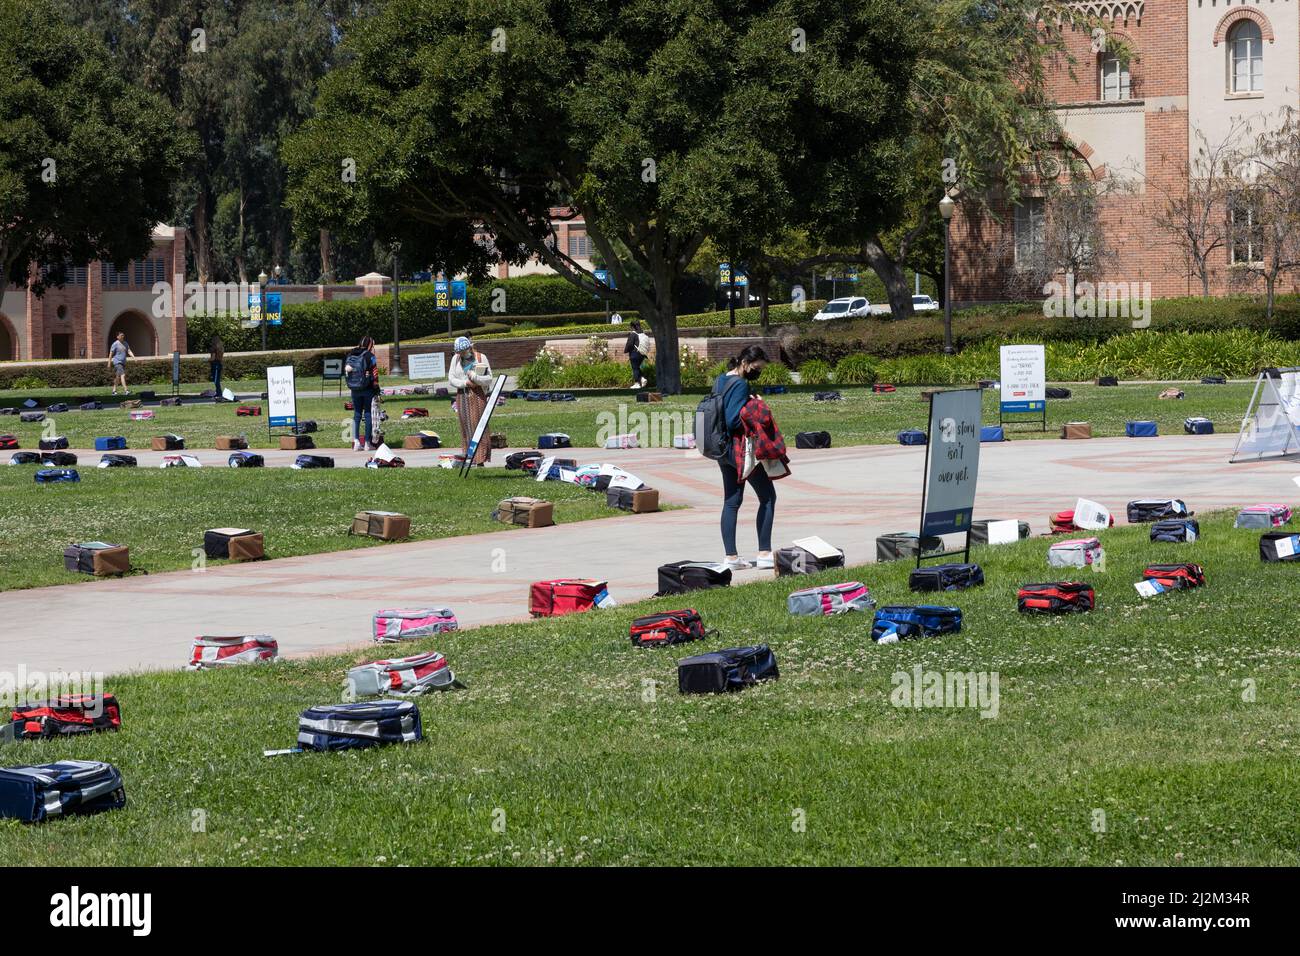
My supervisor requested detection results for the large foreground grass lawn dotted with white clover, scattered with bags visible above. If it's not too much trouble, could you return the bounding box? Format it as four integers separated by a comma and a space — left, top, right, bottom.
0, 515, 1300, 866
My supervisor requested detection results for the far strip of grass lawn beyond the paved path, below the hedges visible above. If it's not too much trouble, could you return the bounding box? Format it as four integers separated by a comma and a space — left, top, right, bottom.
0, 384, 1255, 460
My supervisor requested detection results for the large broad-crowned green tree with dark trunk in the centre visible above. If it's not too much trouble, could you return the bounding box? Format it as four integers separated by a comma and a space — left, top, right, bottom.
286, 0, 928, 393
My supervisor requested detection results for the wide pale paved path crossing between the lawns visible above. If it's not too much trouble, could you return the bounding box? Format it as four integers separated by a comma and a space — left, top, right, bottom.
0, 436, 1300, 672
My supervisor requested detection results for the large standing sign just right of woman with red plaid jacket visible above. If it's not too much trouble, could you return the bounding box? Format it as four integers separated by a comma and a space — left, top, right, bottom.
920, 389, 982, 535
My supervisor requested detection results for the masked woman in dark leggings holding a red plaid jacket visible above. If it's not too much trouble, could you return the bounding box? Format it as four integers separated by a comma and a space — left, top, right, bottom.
714, 345, 789, 570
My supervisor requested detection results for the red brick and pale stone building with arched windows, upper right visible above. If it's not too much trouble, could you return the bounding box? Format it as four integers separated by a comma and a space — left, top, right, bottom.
953, 0, 1300, 302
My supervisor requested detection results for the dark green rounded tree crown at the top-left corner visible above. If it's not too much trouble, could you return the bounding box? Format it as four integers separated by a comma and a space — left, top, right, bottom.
0, 0, 186, 293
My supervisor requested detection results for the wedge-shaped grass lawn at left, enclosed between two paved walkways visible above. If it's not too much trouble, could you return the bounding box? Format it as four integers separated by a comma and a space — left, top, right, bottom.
0, 467, 624, 591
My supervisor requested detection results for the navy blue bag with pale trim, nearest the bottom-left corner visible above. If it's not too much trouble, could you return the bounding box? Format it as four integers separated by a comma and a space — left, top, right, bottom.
0, 760, 126, 823
